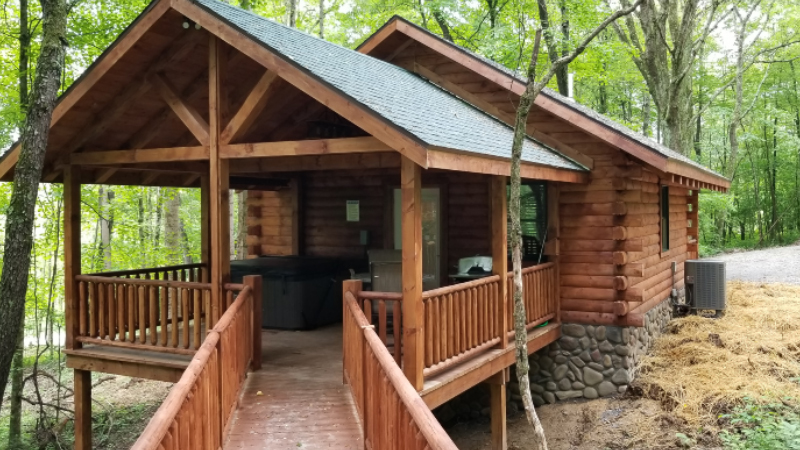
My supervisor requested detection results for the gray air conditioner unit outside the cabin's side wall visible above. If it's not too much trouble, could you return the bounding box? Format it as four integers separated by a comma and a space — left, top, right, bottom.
684, 260, 725, 311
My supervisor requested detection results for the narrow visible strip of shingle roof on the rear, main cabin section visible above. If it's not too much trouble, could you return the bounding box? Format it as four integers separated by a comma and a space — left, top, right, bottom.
368, 16, 724, 178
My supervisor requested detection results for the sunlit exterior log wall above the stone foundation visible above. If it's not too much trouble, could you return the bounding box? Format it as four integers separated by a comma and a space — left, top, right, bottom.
559, 142, 690, 324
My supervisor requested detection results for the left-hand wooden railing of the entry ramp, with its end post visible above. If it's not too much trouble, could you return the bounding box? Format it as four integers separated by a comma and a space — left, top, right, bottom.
132, 277, 261, 450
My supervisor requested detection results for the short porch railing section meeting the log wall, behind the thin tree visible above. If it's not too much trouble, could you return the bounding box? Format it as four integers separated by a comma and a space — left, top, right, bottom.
506, 263, 559, 339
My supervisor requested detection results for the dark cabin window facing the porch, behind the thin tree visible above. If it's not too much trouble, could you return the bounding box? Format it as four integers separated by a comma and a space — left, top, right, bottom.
508, 181, 547, 263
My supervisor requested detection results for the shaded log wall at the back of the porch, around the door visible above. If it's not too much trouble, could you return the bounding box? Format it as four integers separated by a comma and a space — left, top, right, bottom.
247, 169, 491, 272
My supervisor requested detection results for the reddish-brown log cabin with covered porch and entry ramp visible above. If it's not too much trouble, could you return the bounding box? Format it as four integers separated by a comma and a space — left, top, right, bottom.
0, 0, 729, 449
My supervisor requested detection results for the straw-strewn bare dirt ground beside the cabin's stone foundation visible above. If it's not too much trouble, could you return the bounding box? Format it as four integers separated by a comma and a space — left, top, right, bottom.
447, 280, 800, 450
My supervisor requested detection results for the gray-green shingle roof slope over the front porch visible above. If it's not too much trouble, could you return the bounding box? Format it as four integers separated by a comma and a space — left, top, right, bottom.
194, 0, 585, 170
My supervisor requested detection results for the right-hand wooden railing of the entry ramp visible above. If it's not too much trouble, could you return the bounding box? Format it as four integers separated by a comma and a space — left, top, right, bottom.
343, 286, 457, 450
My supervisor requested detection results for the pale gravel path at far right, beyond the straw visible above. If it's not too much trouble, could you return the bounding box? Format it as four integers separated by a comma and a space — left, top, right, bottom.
707, 245, 800, 284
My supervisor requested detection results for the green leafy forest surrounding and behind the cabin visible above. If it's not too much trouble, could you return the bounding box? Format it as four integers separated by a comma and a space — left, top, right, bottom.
0, 0, 800, 448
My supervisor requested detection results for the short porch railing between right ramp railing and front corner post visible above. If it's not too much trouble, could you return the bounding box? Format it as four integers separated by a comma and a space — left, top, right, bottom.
357, 291, 403, 365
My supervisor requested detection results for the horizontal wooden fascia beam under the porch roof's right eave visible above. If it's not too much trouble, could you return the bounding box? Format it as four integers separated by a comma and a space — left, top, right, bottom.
428, 148, 589, 183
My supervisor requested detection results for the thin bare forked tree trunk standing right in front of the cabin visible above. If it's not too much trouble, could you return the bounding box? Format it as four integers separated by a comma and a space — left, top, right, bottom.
509, 0, 644, 449
